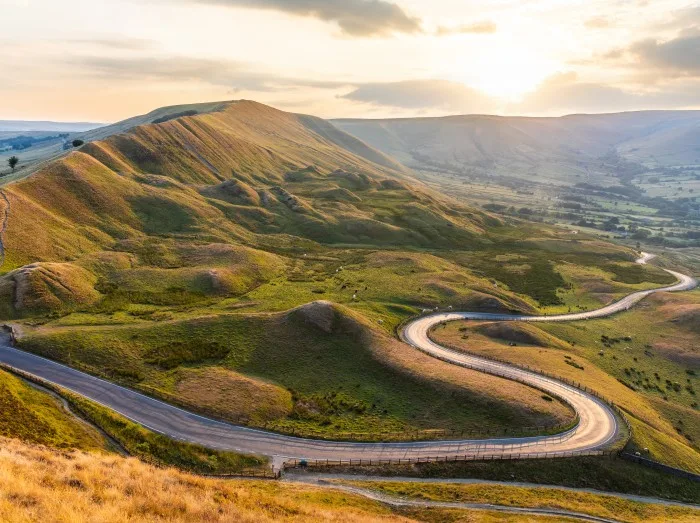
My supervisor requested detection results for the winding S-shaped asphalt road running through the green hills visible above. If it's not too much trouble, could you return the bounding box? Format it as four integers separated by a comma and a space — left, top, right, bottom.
0, 257, 697, 463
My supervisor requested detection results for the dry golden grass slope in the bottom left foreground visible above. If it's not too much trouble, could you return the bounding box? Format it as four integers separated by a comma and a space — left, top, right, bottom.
0, 439, 551, 523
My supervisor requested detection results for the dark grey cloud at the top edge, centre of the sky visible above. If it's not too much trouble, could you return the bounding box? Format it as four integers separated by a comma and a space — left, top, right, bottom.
193, 0, 422, 36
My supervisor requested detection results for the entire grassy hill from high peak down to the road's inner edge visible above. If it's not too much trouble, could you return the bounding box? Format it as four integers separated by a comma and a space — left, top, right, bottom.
0, 101, 676, 437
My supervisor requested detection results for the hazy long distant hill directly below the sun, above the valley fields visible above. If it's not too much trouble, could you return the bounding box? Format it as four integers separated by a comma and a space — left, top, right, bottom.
333, 111, 700, 183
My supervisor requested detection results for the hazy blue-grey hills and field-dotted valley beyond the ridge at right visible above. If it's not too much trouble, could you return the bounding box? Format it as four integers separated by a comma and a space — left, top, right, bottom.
334, 111, 700, 252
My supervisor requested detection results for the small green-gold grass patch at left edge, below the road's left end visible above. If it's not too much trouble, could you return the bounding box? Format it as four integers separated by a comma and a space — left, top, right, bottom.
0, 370, 108, 450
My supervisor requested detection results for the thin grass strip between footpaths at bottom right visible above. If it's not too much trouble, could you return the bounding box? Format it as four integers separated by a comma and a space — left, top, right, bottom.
340, 481, 700, 523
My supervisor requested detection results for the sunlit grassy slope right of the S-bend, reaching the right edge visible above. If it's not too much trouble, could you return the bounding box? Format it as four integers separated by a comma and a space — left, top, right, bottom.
434, 293, 700, 472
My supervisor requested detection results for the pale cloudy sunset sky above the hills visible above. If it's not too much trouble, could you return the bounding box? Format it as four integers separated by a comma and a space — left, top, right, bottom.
0, 0, 700, 122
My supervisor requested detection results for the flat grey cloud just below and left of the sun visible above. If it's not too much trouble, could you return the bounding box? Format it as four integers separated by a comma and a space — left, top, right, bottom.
341, 80, 496, 113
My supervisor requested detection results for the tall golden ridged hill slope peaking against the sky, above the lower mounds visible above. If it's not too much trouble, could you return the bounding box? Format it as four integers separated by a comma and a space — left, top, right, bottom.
0, 102, 498, 269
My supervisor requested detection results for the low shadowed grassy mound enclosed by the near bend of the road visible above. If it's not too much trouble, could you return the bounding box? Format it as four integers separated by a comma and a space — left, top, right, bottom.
21, 303, 571, 438
